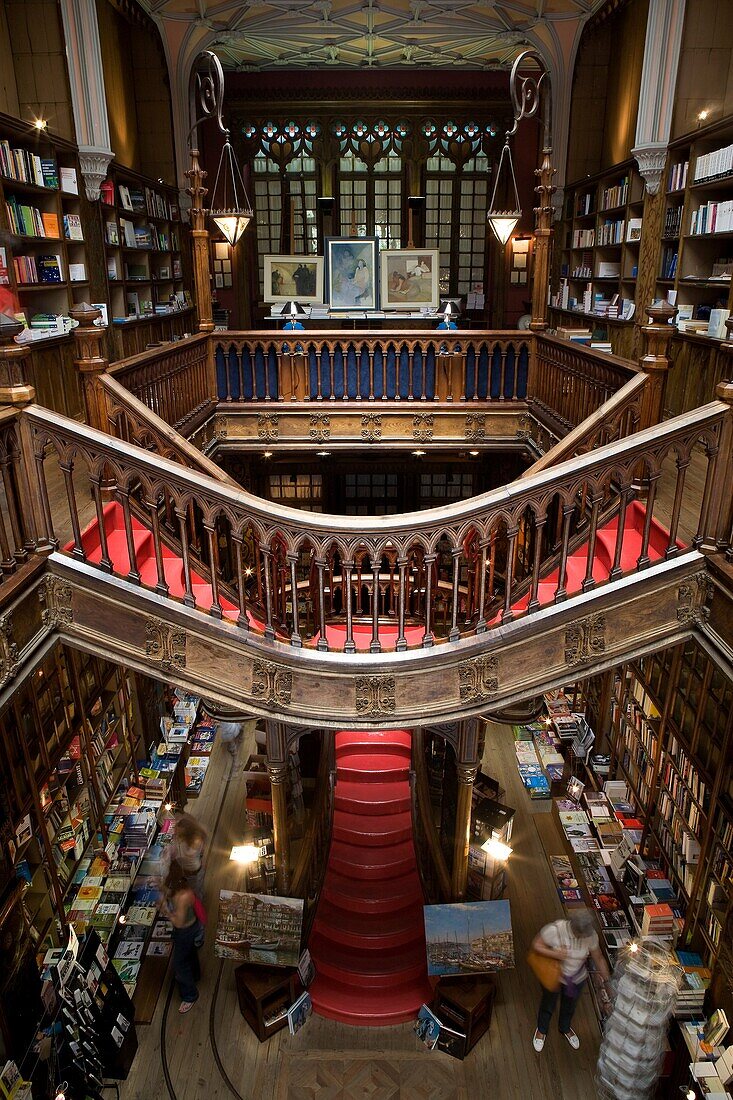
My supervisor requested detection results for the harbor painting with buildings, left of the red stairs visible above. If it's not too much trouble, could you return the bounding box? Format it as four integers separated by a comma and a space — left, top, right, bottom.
214, 890, 303, 966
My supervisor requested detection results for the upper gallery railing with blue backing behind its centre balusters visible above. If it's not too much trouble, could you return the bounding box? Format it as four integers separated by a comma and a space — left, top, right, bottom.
100, 330, 637, 435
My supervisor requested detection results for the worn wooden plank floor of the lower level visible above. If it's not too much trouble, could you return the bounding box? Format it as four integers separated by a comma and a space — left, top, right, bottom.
121, 726, 600, 1100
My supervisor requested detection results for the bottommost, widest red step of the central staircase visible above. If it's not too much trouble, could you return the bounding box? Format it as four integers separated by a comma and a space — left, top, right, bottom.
308, 975, 433, 1027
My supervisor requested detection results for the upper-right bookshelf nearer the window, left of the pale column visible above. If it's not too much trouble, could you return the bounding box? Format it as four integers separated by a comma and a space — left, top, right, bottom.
550, 161, 644, 350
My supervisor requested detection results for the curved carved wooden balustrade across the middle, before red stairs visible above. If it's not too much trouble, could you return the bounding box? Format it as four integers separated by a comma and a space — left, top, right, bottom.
22, 402, 731, 653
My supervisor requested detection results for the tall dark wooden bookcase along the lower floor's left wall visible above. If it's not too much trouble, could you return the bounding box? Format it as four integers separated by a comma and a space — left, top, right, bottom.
0, 645, 145, 952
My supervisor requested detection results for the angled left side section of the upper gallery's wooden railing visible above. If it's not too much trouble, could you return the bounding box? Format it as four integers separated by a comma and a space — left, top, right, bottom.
107, 334, 216, 432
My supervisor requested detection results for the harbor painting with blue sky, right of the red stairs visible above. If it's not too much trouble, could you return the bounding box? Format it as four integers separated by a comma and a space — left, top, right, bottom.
423, 901, 514, 975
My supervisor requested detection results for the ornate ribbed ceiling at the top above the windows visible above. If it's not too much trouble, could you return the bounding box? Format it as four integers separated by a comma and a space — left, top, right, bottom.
138, 0, 608, 72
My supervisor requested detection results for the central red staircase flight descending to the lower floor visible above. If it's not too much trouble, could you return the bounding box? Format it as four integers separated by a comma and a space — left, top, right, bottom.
308, 729, 433, 1027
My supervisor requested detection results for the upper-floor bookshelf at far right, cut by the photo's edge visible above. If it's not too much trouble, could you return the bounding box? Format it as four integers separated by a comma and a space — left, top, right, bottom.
657, 120, 733, 337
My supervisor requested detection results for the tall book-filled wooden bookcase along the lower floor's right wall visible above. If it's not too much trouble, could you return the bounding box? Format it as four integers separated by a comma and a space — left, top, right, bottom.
611, 640, 733, 965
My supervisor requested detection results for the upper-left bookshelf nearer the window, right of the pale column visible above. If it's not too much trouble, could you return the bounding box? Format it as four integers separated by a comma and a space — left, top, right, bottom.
100, 163, 193, 359
